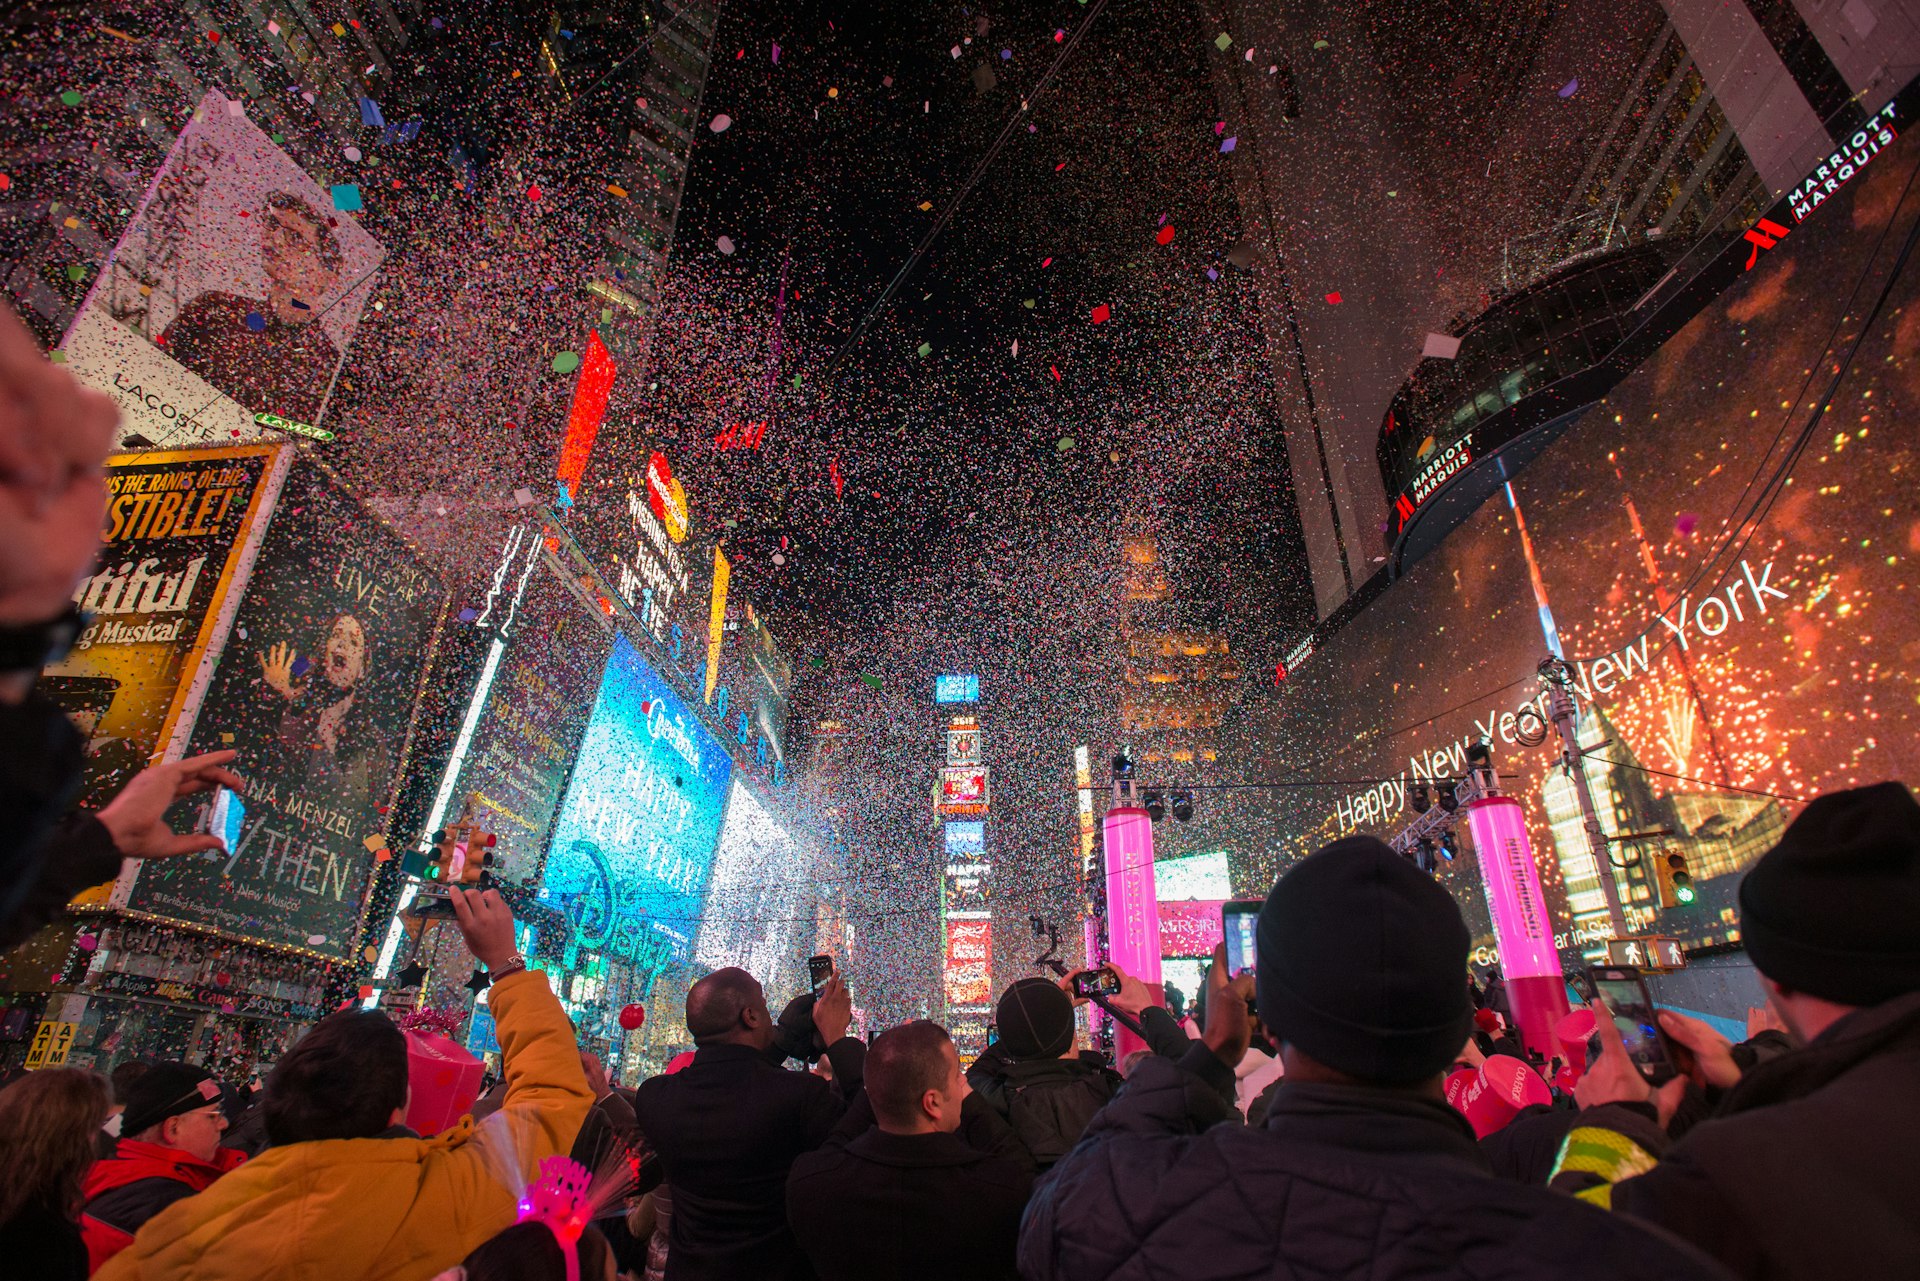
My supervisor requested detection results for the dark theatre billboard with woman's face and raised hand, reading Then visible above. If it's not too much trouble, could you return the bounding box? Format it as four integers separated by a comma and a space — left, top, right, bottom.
129, 457, 445, 958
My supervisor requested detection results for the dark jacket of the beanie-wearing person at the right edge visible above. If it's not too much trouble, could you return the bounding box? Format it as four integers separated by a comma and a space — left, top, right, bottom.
1580, 993, 1920, 1279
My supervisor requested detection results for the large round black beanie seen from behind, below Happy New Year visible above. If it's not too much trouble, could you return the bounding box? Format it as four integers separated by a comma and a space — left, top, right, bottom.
1256, 835, 1473, 1085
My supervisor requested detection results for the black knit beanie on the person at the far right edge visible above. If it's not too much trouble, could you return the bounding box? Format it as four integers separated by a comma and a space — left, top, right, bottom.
1740, 784, 1920, 1006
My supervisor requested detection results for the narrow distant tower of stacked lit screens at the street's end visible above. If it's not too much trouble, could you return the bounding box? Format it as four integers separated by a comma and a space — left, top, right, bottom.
933, 676, 993, 1060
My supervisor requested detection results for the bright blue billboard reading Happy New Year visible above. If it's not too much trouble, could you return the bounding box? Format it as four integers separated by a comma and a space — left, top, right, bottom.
540, 636, 733, 970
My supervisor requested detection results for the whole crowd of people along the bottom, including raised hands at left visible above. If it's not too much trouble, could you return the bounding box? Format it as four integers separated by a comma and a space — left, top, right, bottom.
0, 309, 1920, 1281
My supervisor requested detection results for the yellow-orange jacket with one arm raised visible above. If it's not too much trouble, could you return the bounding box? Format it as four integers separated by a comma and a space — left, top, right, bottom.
94, 970, 593, 1281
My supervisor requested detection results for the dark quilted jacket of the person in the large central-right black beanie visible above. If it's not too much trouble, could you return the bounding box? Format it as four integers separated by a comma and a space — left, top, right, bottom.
1020, 1043, 1724, 1281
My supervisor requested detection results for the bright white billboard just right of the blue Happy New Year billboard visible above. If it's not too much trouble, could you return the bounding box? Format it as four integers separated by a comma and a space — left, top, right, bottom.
693, 778, 814, 993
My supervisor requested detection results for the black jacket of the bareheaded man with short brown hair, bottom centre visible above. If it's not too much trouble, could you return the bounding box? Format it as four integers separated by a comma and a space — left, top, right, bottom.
787, 1093, 1033, 1281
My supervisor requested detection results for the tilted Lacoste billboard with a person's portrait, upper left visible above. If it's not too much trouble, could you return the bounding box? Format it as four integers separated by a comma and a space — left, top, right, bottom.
65, 92, 386, 444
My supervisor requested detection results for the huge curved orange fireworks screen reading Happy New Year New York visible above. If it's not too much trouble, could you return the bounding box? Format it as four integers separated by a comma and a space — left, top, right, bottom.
1236, 127, 1920, 960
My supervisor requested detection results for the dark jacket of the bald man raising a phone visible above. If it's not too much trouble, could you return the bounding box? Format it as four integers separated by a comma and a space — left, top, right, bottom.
634, 1037, 866, 1281
